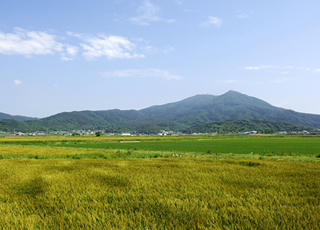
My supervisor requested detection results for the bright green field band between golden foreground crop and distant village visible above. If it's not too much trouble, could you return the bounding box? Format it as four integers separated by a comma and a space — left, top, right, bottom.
0, 135, 320, 160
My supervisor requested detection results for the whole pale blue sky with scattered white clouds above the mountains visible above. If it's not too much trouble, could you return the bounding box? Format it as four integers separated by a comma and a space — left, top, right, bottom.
0, 0, 320, 118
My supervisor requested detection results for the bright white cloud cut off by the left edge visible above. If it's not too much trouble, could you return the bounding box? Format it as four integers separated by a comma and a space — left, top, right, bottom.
0, 28, 63, 56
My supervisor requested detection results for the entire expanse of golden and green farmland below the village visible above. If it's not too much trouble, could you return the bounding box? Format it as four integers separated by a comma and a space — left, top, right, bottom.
0, 136, 320, 229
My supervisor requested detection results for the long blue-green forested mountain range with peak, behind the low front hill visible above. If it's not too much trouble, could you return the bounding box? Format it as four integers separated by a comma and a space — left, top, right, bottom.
0, 91, 320, 133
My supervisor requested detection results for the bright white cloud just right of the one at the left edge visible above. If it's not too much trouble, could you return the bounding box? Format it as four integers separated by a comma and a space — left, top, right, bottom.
80, 35, 144, 59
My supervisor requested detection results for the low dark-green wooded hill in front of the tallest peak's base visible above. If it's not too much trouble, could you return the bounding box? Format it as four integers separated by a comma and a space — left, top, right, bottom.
185, 120, 313, 133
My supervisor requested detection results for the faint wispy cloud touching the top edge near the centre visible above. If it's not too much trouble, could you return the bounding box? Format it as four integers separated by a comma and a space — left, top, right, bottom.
130, 0, 175, 25
